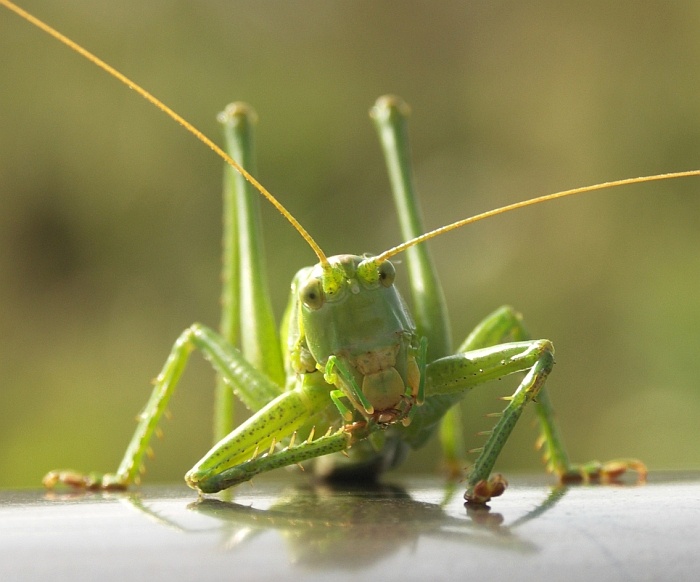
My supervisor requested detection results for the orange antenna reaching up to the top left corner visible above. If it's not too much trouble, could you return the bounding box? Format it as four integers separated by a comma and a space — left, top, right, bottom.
0, 0, 328, 265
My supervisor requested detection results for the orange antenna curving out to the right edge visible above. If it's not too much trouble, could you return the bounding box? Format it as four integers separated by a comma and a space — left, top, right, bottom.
375, 170, 700, 262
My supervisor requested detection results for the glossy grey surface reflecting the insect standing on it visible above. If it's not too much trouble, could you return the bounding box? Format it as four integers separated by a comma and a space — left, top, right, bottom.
0, 473, 700, 581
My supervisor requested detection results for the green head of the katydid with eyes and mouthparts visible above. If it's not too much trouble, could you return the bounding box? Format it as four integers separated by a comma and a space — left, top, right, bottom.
295, 255, 420, 423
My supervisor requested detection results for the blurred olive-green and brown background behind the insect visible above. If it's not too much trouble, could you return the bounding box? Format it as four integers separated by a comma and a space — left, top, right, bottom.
0, 0, 700, 487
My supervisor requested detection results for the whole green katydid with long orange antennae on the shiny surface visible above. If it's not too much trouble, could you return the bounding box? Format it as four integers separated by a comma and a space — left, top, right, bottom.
6, 0, 698, 501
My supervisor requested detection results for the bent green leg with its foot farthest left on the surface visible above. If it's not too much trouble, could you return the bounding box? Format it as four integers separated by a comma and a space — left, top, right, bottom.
43, 324, 282, 489
